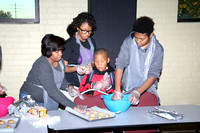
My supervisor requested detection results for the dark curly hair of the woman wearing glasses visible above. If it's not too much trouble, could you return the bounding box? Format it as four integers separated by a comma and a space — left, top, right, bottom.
67, 12, 97, 36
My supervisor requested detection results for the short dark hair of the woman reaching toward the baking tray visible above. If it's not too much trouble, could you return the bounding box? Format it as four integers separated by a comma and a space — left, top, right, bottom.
41, 34, 65, 58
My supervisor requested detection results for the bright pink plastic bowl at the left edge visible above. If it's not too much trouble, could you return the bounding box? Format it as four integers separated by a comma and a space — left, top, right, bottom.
0, 97, 15, 117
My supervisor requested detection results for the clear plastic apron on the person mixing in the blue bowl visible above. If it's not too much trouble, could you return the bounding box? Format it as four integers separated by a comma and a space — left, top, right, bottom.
122, 35, 158, 97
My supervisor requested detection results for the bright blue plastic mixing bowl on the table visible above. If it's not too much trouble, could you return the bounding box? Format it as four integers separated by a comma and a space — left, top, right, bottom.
101, 94, 131, 113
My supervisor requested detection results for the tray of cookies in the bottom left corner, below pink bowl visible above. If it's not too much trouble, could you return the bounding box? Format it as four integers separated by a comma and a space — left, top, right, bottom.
0, 115, 20, 133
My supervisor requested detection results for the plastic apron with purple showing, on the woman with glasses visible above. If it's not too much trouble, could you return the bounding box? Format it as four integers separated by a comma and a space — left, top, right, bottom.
76, 32, 94, 82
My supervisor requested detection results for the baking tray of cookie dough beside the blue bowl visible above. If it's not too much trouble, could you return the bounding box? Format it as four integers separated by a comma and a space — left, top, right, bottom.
65, 106, 115, 121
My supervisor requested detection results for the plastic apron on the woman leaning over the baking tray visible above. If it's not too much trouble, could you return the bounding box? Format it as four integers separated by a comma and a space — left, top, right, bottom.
36, 60, 64, 111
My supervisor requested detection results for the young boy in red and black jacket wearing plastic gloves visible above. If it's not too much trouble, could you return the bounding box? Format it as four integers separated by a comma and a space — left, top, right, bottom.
79, 48, 114, 96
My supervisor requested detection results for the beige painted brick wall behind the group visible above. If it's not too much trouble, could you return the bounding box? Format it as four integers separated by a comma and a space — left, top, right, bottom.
0, 0, 200, 105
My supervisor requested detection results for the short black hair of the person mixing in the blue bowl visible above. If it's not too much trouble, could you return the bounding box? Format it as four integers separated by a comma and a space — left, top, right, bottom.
133, 16, 155, 36
